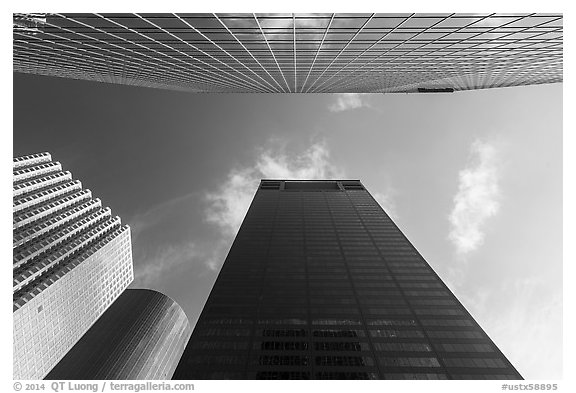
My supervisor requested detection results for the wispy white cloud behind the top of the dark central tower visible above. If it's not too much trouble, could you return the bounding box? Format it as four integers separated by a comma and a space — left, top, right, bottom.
206, 142, 344, 238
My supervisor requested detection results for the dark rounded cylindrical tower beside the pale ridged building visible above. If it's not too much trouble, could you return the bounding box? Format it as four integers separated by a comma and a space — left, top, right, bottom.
46, 289, 192, 380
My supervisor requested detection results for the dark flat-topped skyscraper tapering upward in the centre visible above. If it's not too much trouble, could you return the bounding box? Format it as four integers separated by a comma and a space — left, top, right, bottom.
174, 180, 521, 379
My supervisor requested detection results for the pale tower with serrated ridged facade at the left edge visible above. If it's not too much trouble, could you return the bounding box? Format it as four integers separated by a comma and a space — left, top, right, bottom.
12, 153, 133, 379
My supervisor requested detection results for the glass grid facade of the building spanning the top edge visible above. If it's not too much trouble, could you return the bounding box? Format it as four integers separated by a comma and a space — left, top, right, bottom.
13, 13, 563, 93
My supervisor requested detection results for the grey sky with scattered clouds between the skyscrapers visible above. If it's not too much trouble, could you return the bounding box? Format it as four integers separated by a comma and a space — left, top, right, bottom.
13, 73, 563, 379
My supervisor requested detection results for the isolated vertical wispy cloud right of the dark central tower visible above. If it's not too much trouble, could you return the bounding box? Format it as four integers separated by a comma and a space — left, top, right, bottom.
448, 140, 500, 255
